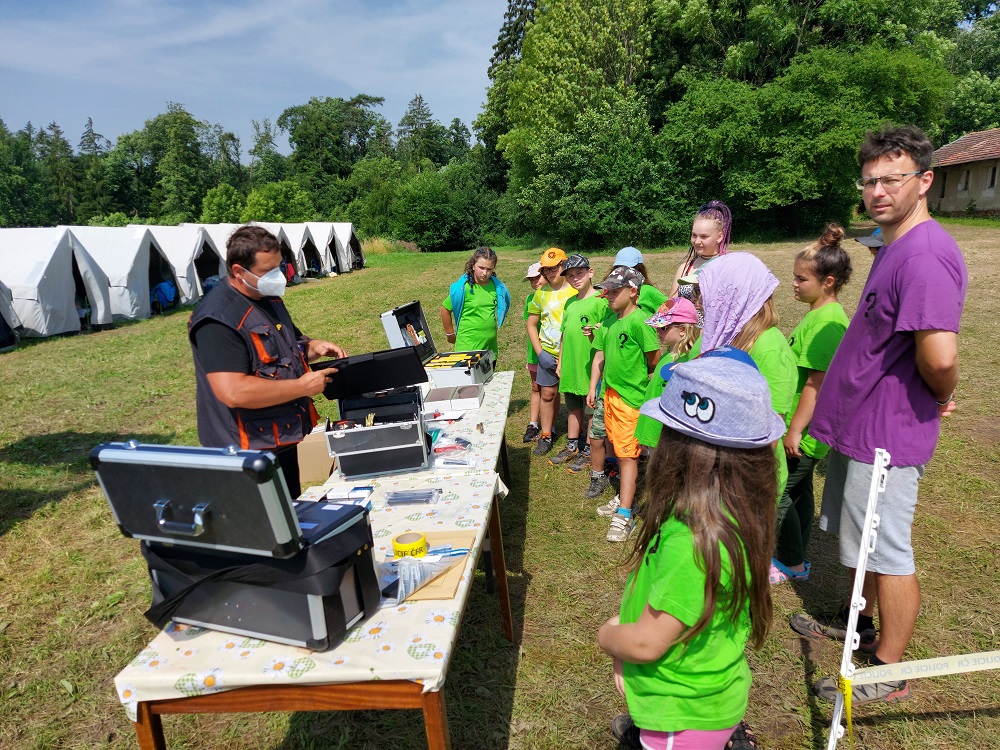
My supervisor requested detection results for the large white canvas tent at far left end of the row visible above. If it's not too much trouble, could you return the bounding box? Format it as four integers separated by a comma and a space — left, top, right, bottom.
0, 227, 112, 337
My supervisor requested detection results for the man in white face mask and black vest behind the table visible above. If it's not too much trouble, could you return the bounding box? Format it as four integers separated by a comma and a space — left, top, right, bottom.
188, 226, 347, 497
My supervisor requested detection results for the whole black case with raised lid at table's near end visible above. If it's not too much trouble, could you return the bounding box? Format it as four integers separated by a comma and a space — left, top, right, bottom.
90, 442, 380, 650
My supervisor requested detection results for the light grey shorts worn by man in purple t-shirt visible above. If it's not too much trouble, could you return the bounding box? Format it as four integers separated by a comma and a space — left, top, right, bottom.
819, 450, 924, 576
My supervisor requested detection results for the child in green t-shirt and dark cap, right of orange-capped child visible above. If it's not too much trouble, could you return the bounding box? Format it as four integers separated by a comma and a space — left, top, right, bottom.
549, 254, 609, 473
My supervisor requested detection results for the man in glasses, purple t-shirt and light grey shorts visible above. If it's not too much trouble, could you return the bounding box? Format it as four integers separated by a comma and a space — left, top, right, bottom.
790, 127, 968, 703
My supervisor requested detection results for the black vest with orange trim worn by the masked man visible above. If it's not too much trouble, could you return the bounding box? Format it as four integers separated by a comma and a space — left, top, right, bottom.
188, 278, 318, 450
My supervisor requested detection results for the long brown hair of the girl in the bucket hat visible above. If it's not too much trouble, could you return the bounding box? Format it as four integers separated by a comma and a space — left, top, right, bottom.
627, 426, 778, 648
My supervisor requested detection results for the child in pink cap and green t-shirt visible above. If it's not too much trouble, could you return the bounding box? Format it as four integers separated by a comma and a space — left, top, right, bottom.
635, 297, 701, 449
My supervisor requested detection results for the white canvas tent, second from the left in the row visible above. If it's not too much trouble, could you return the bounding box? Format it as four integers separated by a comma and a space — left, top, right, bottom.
67, 226, 177, 320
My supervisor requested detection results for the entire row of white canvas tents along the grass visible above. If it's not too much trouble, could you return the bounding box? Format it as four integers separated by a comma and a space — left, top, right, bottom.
0, 221, 365, 337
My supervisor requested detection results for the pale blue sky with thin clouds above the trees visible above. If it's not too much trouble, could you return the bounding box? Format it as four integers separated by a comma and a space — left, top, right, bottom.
0, 0, 507, 152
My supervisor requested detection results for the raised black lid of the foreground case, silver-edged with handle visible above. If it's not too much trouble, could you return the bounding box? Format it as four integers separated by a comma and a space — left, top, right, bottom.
90, 441, 303, 558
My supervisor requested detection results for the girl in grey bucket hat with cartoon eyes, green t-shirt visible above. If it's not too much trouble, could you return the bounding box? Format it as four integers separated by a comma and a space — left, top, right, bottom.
597, 348, 784, 750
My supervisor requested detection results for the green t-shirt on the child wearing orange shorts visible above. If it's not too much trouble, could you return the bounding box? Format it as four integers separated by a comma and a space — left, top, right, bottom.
595, 308, 660, 409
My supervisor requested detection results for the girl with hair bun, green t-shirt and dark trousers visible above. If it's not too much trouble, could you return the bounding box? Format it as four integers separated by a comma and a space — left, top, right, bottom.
770, 224, 851, 583
